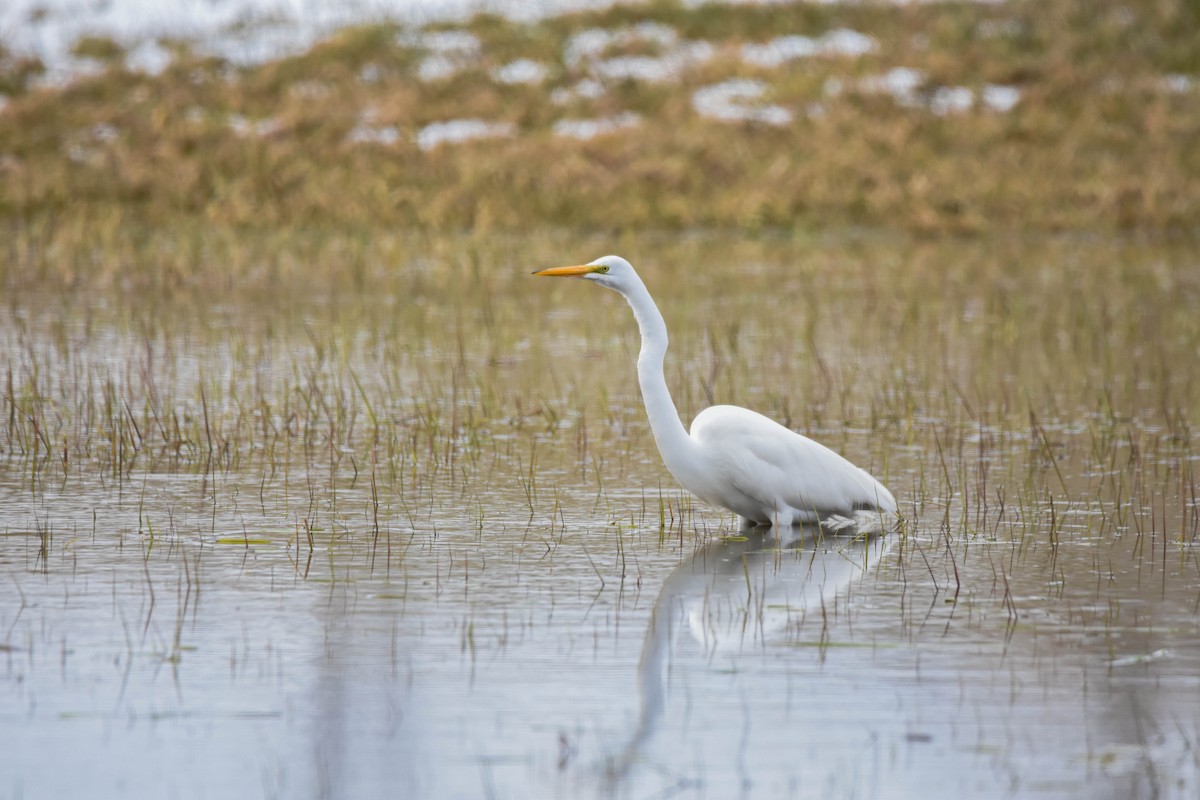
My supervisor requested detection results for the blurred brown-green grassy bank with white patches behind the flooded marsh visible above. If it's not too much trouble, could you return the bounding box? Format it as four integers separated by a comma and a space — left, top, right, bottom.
0, 0, 1200, 237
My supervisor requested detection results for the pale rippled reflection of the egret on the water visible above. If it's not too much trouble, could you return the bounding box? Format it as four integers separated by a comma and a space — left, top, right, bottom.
612, 525, 875, 782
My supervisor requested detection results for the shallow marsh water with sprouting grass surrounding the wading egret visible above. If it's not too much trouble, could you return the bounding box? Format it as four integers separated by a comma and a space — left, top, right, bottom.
0, 231, 1200, 798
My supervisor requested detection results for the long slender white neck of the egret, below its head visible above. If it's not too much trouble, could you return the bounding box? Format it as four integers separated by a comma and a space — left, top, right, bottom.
622, 281, 695, 483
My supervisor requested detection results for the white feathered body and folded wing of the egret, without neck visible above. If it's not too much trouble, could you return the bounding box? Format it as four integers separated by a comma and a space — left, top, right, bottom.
691, 405, 896, 522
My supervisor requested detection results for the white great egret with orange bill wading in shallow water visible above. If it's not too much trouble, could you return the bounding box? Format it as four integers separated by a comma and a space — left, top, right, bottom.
534, 255, 896, 527
